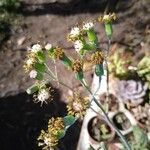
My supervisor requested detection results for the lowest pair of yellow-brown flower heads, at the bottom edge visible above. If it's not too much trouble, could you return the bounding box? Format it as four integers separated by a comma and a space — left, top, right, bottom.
38, 117, 65, 150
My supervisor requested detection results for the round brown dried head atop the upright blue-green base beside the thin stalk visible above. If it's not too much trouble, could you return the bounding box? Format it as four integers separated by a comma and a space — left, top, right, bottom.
91, 51, 104, 64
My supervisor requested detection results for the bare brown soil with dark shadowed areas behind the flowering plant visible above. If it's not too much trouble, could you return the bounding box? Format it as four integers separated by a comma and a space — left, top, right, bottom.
0, 0, 150, 150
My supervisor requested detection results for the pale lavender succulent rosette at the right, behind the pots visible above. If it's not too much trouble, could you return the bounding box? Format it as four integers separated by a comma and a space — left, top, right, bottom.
110, 79, 148, 106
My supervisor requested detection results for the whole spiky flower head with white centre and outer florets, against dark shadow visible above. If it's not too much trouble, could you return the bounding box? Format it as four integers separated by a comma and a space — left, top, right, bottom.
34, 87, 54, 106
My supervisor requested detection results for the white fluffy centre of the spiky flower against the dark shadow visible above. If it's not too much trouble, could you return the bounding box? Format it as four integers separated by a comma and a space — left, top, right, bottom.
37, 89, 50, 102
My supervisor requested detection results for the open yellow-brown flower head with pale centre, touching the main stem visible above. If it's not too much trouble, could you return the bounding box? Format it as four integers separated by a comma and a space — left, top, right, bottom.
67, 92, 89, 119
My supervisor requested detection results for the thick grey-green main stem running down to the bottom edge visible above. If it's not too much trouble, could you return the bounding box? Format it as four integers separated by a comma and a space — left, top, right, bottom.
81, 81, 132, 150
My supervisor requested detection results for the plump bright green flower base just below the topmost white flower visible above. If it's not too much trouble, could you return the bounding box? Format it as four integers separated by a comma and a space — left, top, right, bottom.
87, 29, 98, 45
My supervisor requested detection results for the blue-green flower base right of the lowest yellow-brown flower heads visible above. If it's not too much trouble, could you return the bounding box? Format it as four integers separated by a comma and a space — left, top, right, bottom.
64, 115, 76, 129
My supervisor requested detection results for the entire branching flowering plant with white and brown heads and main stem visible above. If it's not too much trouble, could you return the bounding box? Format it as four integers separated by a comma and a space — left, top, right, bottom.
24, 13, 134, 150
